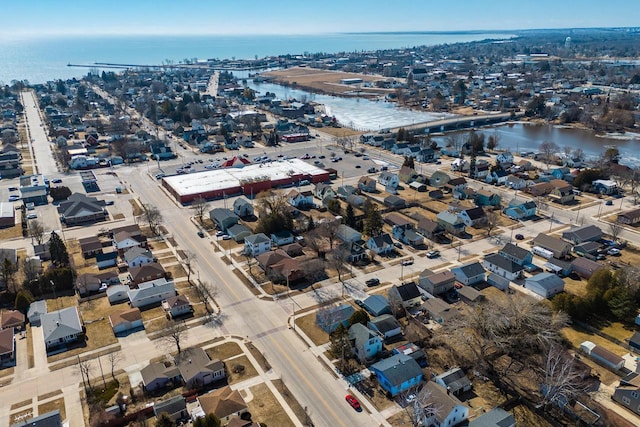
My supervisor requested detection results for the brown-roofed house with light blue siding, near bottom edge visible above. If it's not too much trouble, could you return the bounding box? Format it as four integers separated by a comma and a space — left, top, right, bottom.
421, 381, 469, 427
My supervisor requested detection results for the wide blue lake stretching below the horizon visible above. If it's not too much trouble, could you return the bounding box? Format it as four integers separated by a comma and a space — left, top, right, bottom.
0, 32, 512, 84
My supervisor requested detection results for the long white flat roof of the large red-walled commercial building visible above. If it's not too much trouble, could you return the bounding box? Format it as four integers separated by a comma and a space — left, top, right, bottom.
164, 159, 326, 196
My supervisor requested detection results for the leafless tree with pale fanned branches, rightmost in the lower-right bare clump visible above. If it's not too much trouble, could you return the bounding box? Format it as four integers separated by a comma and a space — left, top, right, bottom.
540, 345, 588, 407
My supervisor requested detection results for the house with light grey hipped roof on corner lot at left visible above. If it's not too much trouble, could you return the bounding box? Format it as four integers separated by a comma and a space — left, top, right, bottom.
40, 306, 84, 351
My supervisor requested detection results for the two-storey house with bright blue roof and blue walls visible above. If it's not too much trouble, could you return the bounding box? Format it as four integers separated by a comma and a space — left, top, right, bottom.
369, 354, 422, 396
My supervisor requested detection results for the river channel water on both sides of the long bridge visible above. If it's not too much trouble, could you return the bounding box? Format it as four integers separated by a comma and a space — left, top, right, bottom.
242, 73, 640, 166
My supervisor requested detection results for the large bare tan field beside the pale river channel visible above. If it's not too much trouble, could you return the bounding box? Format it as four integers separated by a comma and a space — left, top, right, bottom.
263, 67, 391, 96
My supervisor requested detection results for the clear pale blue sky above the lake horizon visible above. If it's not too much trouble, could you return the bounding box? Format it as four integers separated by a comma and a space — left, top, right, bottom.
0, 0, 640, 37
